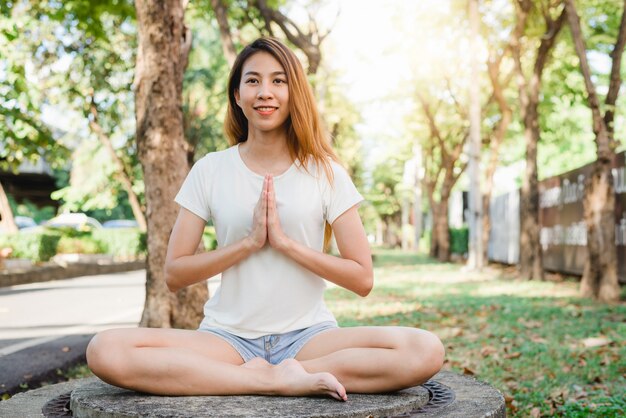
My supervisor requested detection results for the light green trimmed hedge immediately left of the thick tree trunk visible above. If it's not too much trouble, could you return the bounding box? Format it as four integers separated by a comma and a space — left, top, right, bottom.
92, 228, 147, 258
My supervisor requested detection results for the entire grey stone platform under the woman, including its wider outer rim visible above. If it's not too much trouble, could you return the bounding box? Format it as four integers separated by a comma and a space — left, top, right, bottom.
0, 372, 506, 418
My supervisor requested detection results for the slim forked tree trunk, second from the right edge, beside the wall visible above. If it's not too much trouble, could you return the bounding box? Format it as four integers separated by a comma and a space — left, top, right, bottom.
511, 0, 566, 280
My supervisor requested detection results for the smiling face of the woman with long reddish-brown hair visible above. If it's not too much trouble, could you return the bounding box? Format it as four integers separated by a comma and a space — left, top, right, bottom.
235, 51, 289, 136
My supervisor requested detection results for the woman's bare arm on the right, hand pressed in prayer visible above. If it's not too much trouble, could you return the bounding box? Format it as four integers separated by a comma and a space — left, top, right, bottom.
267, 178, 374, 296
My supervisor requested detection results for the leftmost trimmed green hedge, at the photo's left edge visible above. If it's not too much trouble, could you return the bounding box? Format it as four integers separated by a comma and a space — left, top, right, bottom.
0, 231, 61, 262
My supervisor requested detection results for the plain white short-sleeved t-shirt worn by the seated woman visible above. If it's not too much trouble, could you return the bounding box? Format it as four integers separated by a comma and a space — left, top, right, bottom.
175, 145, 363, 338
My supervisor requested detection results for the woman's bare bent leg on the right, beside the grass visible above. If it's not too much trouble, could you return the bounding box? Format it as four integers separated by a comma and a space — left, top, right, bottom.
296, 327, 444, 393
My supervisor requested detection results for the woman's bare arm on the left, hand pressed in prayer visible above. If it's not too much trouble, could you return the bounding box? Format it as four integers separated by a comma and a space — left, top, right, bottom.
165, 176, 267, 292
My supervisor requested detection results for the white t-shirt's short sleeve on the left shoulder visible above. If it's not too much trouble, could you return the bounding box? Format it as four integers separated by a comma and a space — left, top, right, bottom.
174, 157, 211, 222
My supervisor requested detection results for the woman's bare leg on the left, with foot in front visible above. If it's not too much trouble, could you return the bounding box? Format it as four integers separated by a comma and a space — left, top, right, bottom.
87, 328, 346, 400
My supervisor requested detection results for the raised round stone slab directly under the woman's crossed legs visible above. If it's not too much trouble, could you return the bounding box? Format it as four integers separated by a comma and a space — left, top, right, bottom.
70, 381, 429, 418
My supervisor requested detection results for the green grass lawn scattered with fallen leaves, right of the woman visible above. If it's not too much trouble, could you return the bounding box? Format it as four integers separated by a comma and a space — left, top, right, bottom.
326, 250, 626, 417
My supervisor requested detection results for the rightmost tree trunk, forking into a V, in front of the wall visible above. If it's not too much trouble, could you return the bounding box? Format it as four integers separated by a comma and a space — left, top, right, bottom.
565, 0, 626, 302
